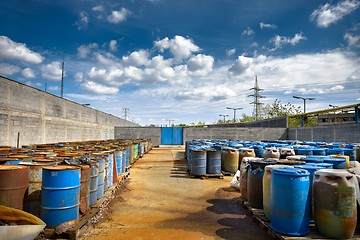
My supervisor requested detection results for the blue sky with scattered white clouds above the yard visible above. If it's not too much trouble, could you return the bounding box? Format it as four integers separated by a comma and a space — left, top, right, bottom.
0, 0, 360, 126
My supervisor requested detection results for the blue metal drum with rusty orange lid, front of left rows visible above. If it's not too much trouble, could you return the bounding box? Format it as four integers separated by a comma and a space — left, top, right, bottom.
41, 166, 81, 227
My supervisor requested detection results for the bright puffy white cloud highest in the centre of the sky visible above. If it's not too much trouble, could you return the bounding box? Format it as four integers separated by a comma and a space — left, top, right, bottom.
154, 36, 201, 61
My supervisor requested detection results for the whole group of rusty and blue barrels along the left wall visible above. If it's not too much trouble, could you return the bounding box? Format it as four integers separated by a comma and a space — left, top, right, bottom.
0, 140, 152, 227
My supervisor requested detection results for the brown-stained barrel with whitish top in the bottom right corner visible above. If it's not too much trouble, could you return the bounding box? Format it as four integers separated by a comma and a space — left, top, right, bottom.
313, 169, 358, 239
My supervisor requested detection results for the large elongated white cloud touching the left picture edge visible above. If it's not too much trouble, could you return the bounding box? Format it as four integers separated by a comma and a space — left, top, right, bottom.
0, 36, 44, 64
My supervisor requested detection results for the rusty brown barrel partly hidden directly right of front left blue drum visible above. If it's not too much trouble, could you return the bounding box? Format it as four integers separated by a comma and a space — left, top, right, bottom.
80, 165, 91, 213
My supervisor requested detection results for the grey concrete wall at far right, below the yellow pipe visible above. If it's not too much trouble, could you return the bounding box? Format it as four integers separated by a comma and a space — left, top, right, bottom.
288, 124, 360, 143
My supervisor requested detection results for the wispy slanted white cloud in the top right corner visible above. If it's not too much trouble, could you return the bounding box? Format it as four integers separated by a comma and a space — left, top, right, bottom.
310, 0, 360, 28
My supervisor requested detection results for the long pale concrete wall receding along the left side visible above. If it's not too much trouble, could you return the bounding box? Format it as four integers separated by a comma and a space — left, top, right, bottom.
0, 76, 138, 146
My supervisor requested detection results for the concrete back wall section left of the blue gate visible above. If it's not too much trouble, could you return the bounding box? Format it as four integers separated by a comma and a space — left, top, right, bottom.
115, 127, 161, 146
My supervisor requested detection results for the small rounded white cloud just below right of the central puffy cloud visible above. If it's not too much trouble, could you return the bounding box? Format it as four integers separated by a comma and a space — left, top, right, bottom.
188, 54, 214, 76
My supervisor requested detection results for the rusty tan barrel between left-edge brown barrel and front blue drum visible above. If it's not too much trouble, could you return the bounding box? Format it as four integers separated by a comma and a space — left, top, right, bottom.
20, 162, 56, 217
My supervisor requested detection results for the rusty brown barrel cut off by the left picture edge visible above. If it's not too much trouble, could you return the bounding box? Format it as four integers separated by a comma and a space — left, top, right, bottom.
0, 165, 30, 210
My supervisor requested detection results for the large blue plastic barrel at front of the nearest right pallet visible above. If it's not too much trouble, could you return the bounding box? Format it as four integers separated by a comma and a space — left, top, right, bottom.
270, 168, 310, 236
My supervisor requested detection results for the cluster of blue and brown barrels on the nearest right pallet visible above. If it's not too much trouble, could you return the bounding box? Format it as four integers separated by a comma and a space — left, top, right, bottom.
240, 159, 358, 238
